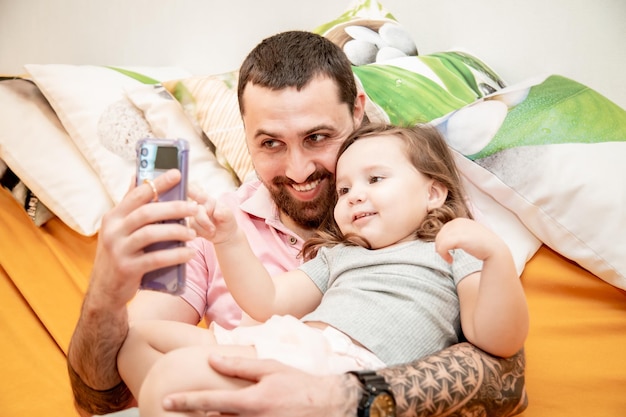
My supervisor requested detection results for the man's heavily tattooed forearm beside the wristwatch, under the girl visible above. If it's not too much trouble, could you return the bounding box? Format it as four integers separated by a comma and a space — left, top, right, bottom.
377, 343, 528, 417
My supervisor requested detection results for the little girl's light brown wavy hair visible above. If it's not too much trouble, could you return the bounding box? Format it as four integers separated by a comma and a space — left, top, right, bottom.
302, 123, 472, 259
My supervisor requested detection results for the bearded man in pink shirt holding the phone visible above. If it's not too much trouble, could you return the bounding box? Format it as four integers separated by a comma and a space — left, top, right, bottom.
68, 31, 526, 417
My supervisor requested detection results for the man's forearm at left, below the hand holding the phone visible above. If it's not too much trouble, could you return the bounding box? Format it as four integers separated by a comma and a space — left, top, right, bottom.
67, 290, 133, 414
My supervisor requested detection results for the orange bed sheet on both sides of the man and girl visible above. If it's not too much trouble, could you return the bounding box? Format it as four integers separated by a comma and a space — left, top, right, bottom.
0, 190, 626, 417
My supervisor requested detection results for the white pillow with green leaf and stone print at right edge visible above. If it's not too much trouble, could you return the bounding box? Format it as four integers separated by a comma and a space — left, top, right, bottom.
436, 75, 626, 289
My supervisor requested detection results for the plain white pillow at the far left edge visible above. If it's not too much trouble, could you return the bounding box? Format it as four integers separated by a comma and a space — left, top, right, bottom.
0, 79, 113, 236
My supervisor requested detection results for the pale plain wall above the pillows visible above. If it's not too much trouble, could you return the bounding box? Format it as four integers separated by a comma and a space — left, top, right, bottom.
0, 0, 626, 108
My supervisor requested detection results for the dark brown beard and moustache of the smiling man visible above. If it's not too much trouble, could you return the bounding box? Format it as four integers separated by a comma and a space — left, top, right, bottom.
267, 170, 335, 229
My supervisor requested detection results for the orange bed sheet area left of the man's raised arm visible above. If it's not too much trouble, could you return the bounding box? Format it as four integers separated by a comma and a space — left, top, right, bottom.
0, 189, 96, 417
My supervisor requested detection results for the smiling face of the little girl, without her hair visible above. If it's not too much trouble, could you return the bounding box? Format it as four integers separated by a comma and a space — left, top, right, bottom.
334, 135, 447, 249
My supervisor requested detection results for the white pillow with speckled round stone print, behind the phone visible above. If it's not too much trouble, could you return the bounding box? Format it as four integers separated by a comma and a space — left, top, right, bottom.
25, 64, 189, 203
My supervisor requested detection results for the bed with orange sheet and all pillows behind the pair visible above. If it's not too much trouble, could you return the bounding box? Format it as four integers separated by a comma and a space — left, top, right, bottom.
0, 0, 626, 417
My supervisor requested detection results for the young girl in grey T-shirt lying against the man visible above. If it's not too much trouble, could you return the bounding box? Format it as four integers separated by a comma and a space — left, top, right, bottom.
118, 124, 528, 416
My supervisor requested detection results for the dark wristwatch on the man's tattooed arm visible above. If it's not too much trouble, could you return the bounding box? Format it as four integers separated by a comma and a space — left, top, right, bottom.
349, 371, 396, 417
